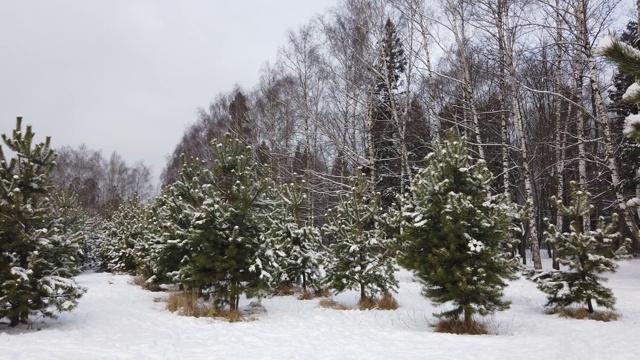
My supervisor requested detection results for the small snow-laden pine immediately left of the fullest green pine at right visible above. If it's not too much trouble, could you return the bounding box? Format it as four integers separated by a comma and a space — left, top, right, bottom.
324, 171, 398, 304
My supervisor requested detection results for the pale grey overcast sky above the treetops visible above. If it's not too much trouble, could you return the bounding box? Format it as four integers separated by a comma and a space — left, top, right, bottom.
0, 0, 338, 184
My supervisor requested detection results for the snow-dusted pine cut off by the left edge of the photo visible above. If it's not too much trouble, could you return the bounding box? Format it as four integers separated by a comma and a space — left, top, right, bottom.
0, 118, 84, 326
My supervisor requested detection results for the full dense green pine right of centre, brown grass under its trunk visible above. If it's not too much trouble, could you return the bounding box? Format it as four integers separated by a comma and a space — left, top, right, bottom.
399, 132, 517, 325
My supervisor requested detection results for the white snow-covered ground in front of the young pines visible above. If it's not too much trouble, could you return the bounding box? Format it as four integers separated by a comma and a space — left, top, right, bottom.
0, 260, 640, 360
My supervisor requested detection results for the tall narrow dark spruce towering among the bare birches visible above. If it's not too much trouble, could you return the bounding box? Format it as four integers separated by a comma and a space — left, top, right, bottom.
370, 19, 407, 209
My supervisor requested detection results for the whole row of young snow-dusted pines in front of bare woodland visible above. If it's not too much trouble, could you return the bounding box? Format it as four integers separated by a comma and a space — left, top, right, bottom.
0, 119, 626, 333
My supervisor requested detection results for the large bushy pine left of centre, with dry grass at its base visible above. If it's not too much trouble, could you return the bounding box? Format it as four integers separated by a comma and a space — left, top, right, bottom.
159, 135, 274, 311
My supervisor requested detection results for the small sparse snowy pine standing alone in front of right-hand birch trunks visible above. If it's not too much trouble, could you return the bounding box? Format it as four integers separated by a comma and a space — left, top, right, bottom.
532, 182, 629, 313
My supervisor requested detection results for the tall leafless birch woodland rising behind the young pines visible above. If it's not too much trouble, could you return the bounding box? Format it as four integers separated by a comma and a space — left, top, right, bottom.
162, 0, 640, 269
